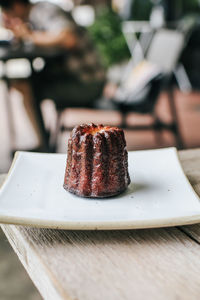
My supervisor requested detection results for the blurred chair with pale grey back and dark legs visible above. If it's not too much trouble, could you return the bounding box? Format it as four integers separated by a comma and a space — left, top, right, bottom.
113, 29, 184, 149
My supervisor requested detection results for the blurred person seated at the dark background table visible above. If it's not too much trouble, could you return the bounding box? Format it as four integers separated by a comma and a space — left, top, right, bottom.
0, 0, 105, 149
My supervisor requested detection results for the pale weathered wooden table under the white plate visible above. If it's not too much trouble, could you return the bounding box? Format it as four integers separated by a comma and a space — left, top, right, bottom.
1, 149, 200, 300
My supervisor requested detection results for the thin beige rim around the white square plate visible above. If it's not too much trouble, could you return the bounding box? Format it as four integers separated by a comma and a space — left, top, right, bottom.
0, 147, 200, 230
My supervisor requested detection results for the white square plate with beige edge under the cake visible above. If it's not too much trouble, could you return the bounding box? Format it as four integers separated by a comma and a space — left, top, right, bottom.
0, 148, 200, 230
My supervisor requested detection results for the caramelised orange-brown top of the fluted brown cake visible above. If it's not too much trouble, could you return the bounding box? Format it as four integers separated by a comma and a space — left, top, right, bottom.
72, 123, 123, 136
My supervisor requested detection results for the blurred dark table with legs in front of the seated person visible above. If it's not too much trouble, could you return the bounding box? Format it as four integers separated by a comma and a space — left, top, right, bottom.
0, 44, 66, 153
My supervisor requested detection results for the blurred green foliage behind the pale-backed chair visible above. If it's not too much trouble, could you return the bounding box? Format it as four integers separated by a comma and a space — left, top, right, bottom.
89, 8, 130, 67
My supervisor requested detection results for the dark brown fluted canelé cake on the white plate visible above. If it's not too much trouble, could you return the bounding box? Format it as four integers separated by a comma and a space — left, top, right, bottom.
63, 124, 130, 197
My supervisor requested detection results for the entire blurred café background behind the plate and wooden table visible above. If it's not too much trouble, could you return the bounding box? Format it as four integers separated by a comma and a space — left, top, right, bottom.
0, 0, 200, 300
